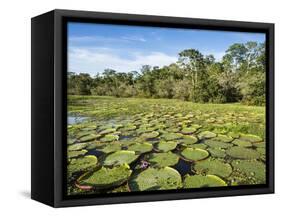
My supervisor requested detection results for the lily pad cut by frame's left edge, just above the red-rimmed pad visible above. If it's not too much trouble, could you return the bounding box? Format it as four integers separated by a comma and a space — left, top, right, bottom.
67, 155, 98, 174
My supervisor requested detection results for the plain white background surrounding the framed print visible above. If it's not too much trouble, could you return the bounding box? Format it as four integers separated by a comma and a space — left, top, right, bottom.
0, 0, 281, 217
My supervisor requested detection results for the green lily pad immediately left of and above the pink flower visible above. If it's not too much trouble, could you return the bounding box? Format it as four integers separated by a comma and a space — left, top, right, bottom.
103, 150, 139, 166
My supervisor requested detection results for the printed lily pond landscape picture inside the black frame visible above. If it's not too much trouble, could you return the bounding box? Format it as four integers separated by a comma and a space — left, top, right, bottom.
67, 22, 267, 195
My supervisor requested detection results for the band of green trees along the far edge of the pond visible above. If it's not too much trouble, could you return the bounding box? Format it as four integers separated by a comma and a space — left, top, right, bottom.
68, 42, 266, 105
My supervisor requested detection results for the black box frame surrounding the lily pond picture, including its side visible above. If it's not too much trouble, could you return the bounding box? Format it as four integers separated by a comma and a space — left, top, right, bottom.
31, 10, 274, 207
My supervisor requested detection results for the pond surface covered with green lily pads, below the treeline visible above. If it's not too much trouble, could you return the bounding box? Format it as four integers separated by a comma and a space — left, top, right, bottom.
65, 96, 266, 195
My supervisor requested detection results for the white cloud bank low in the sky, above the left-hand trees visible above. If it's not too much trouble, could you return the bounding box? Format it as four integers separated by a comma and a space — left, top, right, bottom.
68, 47, 177, 74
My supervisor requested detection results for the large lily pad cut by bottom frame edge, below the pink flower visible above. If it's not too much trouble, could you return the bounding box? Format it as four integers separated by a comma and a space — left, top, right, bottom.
129, 167, 182, 191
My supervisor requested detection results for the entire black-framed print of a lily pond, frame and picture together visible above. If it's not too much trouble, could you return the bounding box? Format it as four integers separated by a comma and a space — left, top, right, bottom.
31, 10, 274, 207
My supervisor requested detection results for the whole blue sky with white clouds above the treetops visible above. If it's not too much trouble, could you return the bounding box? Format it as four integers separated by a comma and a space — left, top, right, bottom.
68, 22, 265, 75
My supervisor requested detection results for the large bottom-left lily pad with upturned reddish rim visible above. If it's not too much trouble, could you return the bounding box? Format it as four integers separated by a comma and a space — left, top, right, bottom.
78, 164, 132, 189
